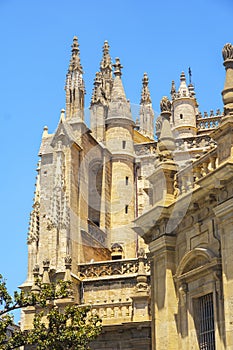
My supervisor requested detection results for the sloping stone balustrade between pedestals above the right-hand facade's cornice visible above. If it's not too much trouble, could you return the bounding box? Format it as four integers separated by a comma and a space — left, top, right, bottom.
174, 148, 218, 197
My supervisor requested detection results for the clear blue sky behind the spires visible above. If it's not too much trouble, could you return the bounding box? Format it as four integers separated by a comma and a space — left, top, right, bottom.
0, 0, 233, 320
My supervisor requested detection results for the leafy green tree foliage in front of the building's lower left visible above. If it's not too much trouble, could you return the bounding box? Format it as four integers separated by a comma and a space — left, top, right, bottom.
0, 275, 102, 350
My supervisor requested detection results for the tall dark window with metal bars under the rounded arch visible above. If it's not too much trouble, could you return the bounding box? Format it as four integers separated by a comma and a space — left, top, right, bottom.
195, 293, 215, 350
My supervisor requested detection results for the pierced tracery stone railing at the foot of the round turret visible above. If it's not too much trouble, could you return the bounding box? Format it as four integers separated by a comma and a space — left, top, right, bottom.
78, 259, 150, 279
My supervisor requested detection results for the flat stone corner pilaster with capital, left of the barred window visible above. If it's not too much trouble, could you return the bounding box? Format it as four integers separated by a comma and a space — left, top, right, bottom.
149, 235, 178, 350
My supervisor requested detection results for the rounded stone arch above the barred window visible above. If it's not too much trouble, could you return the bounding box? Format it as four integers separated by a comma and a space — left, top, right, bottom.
176, 248, 216, 278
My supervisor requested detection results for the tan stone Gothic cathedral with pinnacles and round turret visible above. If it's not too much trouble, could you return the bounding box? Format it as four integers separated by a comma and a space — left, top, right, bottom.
21, 37, 233, 350
